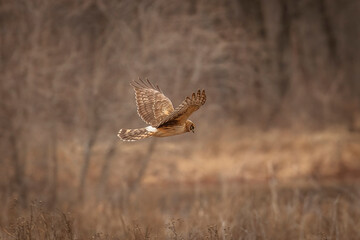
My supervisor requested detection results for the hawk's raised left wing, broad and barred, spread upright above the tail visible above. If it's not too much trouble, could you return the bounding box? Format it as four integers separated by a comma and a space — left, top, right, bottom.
131, 79, 174, 126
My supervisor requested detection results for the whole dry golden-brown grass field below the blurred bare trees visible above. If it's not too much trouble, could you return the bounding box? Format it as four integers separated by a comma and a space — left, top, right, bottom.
0, 129, 360, 239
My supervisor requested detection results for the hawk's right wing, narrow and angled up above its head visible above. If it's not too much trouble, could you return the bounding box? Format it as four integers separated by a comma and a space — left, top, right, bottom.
159, 90, 206, 126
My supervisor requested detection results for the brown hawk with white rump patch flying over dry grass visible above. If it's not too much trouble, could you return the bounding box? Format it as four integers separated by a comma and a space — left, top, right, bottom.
118, 79, 206, 141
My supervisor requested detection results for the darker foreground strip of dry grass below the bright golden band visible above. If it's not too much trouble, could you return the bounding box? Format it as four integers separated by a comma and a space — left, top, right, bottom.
1, 181, 360, 240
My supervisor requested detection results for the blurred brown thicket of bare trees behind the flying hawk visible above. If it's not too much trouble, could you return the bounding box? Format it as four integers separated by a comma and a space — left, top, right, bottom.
0, 0, 360, 206
